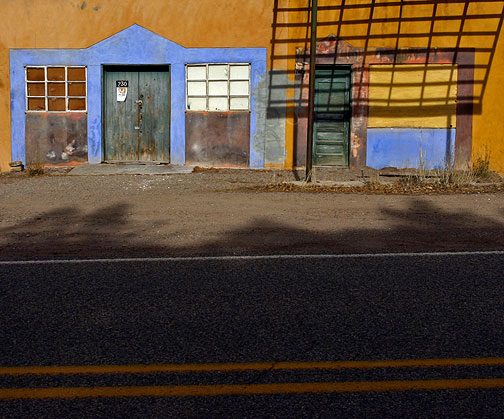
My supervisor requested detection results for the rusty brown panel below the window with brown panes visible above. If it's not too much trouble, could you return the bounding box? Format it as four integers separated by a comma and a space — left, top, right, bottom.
25, 112, 88, 165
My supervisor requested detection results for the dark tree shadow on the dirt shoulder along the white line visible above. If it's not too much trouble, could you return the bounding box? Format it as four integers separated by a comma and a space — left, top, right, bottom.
0, 198, 504, 259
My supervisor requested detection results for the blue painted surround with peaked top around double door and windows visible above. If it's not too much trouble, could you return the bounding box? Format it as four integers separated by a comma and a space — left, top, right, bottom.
10, 25, 266, 168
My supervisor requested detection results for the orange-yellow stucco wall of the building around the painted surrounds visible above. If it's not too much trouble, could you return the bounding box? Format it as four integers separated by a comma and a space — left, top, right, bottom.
0, 0, 504, 173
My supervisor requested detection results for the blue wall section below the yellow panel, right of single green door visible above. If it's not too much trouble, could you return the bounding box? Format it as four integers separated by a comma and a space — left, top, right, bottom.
366, 128, 456, 169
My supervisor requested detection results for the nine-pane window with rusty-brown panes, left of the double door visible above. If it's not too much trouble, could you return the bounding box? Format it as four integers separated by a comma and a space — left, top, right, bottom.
25, 66, 87, 112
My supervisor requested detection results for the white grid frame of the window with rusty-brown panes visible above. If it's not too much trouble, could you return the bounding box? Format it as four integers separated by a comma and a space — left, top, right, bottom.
25, 65, 88, 113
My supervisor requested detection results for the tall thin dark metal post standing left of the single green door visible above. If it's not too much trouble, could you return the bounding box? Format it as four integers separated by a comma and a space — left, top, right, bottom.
305, 0, 318, 182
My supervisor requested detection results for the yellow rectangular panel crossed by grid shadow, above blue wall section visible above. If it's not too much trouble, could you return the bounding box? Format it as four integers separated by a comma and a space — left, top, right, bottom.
368, 64, 457, 128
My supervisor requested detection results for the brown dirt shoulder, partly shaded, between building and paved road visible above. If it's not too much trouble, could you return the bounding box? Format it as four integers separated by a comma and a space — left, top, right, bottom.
0, 170, 504, 260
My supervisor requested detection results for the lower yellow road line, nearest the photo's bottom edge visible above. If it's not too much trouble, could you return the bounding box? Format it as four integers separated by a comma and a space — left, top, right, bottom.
0, 378, 504, 400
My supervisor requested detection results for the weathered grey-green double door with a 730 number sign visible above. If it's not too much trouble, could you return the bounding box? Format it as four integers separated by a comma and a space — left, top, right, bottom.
104, 66, 170, 162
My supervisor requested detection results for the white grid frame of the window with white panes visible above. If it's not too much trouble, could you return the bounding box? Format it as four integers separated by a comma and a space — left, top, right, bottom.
185, 63, 251, 112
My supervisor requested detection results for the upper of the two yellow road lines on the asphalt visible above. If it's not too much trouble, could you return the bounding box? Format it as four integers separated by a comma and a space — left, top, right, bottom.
0, 358, 504, 376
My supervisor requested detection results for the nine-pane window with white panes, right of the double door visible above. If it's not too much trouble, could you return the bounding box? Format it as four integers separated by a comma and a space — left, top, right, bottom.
186, 64, 250, 111
